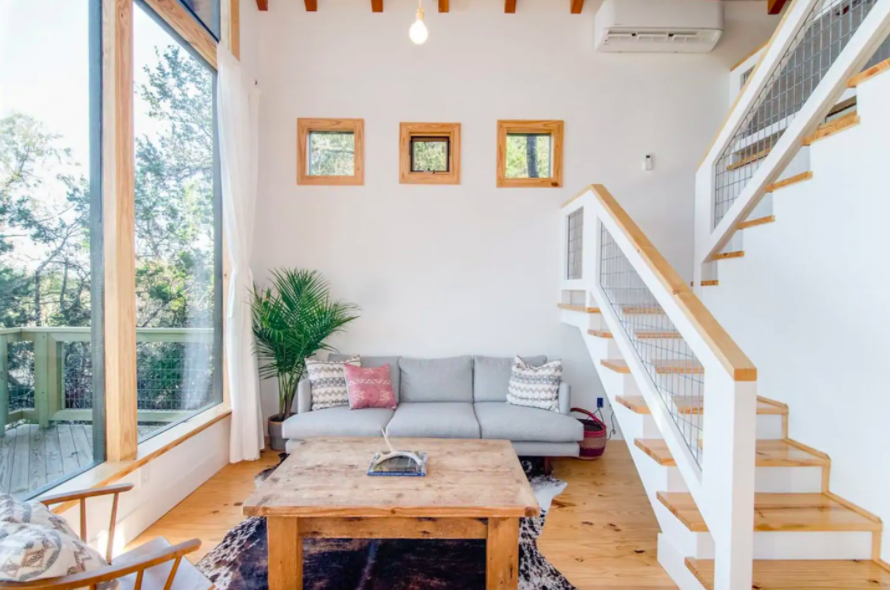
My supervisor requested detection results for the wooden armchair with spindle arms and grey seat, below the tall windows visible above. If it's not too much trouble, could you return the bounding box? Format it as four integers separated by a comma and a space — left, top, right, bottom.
0, 483, 213, 590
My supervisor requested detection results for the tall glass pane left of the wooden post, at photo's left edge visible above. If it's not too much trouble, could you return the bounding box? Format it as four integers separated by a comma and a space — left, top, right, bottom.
0, 0, 105, 497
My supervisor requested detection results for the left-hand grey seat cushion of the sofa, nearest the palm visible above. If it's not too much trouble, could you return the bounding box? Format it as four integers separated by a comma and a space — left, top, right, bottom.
281, 406, 393, 439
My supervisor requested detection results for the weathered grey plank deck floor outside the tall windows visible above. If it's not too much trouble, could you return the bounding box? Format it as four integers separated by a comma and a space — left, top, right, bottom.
0, 423, 161, 497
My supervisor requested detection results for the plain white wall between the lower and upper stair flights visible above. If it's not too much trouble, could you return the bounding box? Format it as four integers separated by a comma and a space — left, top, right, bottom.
704, 74, 890, 560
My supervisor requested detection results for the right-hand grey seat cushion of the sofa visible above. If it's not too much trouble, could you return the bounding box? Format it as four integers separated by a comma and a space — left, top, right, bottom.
474, 402, 584, 442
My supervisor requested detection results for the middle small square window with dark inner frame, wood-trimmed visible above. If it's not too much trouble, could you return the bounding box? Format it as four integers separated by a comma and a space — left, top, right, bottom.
399, 123, 460, 184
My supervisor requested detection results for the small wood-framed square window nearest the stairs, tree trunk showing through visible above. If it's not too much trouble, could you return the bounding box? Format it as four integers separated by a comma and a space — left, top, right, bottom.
497, 121, 563, 188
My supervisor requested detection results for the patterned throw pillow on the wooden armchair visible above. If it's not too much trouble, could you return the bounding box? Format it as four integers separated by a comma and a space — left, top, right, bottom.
0, 495, 119, 590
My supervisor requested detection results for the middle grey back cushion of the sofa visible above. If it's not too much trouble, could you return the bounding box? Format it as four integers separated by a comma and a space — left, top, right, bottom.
399, 356, 473, 403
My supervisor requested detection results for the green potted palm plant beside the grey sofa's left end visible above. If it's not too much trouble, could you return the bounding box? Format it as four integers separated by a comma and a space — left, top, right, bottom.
251, 269, 358, 451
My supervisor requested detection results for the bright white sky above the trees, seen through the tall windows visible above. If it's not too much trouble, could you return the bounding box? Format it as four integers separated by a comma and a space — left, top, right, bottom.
0, 0, 182, 169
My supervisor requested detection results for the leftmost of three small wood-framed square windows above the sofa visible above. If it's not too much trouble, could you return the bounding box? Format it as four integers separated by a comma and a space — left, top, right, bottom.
297, 119, 365, 185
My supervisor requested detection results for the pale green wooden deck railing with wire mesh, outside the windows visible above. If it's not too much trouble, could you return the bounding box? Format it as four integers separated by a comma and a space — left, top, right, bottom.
0, 327, 213, 436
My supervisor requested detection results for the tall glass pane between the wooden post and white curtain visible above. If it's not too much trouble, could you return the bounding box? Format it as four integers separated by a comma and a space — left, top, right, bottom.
134, 5, 222, 440
